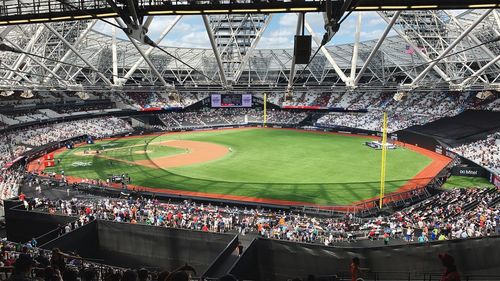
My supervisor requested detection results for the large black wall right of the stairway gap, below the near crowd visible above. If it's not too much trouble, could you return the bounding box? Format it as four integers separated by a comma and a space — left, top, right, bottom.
231, 236, 500, 281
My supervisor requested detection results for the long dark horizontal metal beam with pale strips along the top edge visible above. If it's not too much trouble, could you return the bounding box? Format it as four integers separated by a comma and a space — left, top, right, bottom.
0, 0, 498, 25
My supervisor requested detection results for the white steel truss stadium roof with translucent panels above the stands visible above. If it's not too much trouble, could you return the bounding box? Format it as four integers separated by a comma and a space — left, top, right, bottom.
0, 9, 500, 91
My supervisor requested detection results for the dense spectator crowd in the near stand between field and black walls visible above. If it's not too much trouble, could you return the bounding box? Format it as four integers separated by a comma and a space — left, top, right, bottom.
21, 188, 500, 245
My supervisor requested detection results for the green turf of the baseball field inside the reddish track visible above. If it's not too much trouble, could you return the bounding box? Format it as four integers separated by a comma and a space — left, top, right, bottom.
49, 128, 432, 205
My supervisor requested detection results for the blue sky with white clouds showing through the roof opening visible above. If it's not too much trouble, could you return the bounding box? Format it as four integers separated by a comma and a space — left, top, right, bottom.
94, 12, 394, 49
